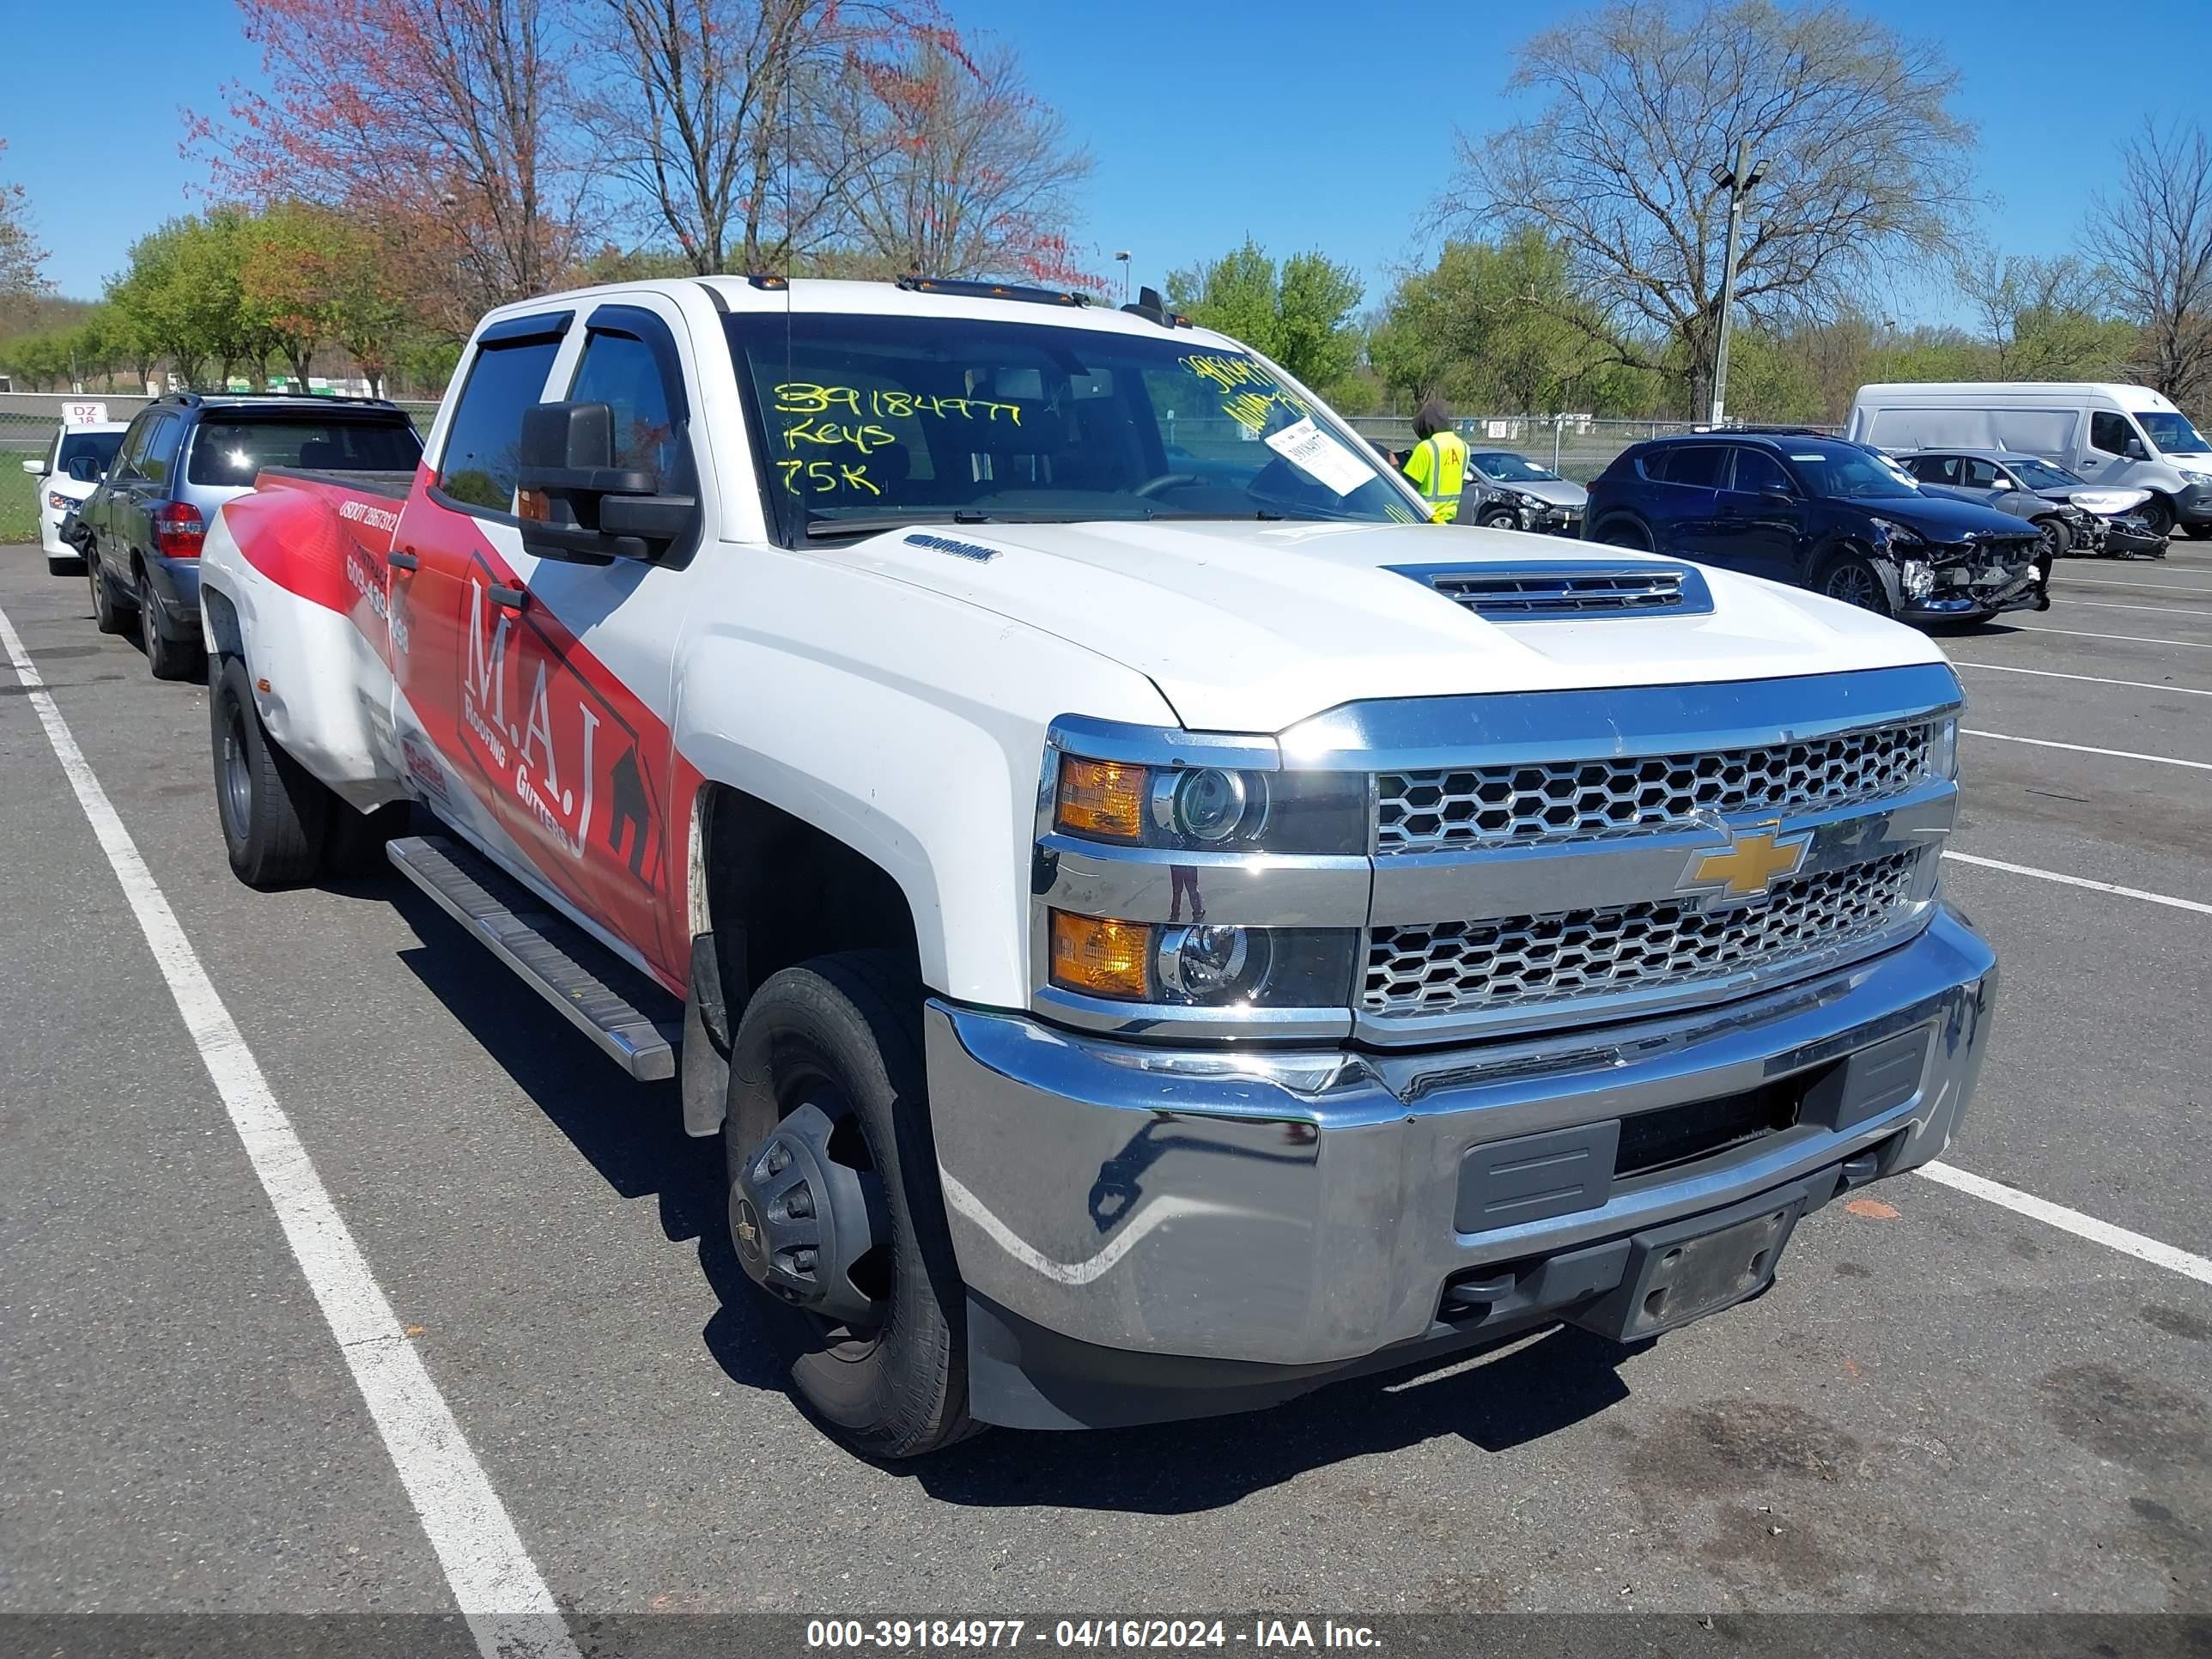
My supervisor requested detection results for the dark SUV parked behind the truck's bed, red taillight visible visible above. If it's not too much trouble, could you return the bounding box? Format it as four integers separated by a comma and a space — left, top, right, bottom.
73, 392, 422, 679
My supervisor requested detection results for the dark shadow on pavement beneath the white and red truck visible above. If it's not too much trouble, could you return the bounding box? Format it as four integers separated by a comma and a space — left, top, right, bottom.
378, 880, 1635, 1516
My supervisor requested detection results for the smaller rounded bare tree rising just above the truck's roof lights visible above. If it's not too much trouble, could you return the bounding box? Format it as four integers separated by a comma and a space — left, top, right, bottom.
842, 42, 1103, 288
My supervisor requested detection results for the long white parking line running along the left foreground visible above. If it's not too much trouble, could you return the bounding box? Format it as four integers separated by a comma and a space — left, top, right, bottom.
0, 611, 580, 1659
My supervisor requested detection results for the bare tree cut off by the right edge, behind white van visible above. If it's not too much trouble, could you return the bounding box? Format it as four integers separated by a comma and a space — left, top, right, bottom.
2084, 119, 2212, 404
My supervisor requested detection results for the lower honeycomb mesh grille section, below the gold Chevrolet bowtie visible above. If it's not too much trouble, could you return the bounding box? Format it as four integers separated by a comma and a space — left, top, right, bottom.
1360, 849, 1931, 1020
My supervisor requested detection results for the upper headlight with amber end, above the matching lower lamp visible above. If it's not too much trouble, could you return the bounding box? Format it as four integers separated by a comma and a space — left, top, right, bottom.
1053, 754, 1367, 854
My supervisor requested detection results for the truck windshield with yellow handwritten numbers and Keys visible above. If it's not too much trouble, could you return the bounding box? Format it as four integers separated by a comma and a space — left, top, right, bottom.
728, 312, 1420, 542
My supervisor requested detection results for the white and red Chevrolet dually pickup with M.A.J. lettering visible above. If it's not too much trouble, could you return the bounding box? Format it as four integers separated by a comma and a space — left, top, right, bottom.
199, 276, 1997, 1458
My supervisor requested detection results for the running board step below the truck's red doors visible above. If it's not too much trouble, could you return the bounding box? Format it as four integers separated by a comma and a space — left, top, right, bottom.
385, 836, 684, 1082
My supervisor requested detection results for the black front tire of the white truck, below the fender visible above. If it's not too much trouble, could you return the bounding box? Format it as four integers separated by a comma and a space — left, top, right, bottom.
723, 951, 975, 1458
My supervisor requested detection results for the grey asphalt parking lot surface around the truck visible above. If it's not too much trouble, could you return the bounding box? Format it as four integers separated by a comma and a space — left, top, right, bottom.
0, 542, 2212, 1621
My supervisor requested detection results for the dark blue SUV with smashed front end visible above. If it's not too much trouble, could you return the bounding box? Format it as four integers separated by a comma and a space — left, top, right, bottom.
1582, 431, 2048, 622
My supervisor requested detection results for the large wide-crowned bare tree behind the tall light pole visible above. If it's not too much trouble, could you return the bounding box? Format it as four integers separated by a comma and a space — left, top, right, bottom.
1436, 0, 1973, 407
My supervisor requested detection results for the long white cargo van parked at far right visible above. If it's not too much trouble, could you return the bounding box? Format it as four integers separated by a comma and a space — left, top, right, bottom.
1844, 380, 2212, 535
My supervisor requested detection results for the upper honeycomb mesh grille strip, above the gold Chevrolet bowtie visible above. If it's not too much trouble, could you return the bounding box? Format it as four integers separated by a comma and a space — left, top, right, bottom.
1376, 721, 1936, 858
